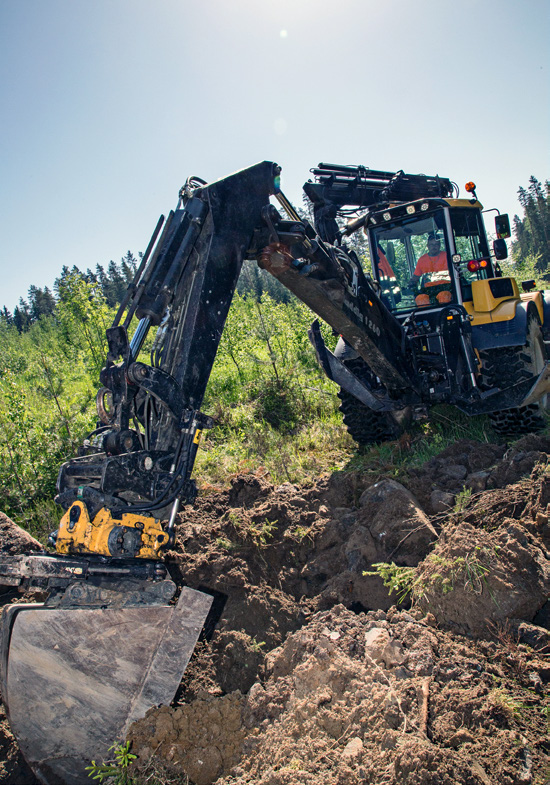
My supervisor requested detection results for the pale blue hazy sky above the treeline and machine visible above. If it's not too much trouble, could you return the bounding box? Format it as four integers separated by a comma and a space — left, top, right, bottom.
0, 0, 550, 309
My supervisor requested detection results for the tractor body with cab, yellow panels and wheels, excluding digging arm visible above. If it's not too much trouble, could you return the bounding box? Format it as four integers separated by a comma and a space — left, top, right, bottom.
304, 163, 550, 444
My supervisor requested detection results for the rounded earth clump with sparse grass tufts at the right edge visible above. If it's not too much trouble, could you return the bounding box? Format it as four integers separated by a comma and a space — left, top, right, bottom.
415, 454, 550, 635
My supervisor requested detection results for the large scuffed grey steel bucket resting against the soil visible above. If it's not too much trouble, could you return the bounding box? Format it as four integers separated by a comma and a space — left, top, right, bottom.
1, 588, 212, 785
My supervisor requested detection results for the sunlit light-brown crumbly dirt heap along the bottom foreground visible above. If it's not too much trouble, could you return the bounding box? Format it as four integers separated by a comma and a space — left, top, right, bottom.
131, 605, 550, 785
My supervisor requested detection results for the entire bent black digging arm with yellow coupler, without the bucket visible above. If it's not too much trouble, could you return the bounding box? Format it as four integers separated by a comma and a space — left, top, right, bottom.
52, 162, 417, 559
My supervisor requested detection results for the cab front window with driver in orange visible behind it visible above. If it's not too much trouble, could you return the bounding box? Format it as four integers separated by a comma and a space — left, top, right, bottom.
370, 210, 455, 312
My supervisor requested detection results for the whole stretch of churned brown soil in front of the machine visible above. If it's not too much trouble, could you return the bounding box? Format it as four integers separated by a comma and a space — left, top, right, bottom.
0, 436, 550, 785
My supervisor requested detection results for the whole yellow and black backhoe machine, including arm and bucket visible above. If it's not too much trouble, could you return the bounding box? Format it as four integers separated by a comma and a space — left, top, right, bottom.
0, 161, 550, 785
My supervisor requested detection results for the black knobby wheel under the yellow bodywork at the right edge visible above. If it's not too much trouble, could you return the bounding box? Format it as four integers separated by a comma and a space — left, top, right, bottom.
480, 314, 548, 436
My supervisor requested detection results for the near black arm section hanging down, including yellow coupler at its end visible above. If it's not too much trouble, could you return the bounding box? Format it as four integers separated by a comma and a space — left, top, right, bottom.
56, 162, 286, 558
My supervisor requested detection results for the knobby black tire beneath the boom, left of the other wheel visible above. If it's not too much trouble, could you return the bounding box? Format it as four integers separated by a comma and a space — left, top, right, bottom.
338, 358, 403, 445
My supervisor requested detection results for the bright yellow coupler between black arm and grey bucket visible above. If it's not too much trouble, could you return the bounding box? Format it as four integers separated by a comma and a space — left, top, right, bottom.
56, 501, 169, 559
